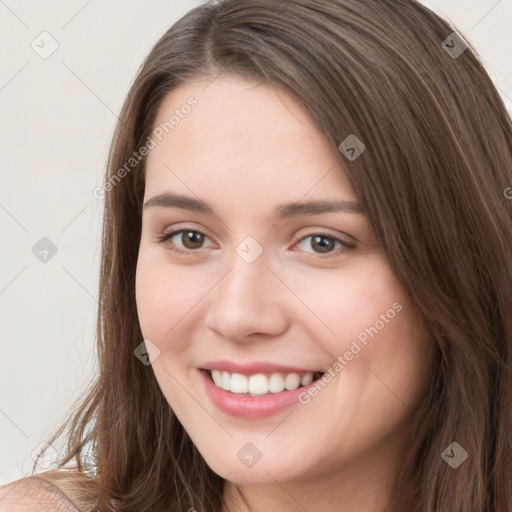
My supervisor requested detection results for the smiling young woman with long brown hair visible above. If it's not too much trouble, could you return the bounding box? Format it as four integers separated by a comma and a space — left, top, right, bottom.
0, 0, 512, 512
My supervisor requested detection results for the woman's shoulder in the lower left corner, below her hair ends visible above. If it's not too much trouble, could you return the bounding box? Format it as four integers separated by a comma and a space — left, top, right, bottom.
0, 472, 79, 512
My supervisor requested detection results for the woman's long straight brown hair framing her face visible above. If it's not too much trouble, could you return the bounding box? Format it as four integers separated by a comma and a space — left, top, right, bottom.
27, 0, 512, 512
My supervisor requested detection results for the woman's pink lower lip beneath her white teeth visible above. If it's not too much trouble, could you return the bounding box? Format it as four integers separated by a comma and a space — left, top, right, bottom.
199, 370, 317, 419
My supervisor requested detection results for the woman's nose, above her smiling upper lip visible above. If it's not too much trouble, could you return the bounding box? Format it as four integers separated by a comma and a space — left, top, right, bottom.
205, 246, 292, 342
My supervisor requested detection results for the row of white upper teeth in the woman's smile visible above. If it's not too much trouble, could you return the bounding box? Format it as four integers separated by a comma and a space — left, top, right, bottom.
210, 370, 313, 396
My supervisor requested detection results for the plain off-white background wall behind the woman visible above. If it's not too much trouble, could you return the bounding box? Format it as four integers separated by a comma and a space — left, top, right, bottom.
0, 0, 512, 484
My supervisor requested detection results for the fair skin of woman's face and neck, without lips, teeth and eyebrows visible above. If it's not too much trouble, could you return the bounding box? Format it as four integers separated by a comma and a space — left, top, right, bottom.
136, 76, 432, 512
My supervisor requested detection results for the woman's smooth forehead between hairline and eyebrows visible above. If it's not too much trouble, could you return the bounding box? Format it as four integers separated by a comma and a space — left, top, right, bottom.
146, 76, 355, 206
